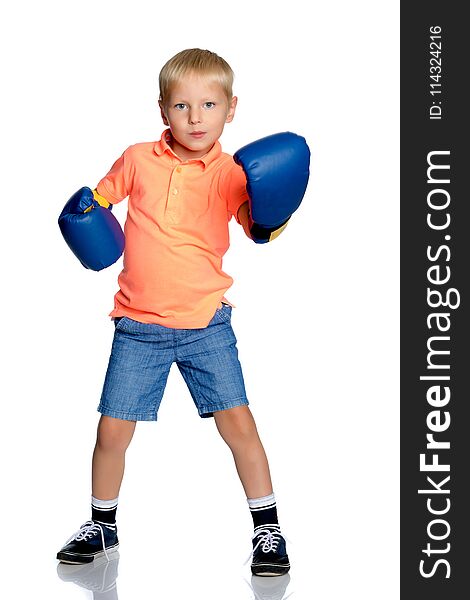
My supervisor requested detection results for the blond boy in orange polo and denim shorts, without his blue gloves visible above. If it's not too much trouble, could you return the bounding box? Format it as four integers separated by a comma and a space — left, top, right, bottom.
57, 49, 308, 575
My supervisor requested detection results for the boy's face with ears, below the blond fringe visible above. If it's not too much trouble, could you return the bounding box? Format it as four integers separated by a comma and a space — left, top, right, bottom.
159, 73, 237, 160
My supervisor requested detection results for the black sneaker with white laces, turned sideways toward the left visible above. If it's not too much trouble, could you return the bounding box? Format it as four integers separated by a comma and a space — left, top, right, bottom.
57, 521, 119, 565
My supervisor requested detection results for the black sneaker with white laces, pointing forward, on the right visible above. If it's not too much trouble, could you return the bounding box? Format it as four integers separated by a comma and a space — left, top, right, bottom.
251, 525, 290, 577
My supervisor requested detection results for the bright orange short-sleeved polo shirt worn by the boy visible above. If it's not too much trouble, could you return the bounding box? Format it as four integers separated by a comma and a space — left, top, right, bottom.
97, 129, 248, 329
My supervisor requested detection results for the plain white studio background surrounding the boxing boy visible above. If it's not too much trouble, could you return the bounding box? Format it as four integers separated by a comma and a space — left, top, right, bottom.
0, 0, 399, 600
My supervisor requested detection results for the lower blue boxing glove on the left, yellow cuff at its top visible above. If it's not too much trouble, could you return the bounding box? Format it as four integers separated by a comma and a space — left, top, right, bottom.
59, 187, 124, 271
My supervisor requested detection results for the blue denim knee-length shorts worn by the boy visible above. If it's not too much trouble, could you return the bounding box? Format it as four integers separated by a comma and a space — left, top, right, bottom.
98, 304, 248, 421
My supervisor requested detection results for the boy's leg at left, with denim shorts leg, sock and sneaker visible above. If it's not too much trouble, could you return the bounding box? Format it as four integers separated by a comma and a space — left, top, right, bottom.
57, 317, 175, 563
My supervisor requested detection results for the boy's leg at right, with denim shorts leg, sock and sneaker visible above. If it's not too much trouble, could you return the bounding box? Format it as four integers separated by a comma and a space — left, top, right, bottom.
176, 304, 289, 575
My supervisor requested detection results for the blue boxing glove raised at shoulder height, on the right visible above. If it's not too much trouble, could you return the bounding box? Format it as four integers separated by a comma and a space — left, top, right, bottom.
233, 131, 310, 244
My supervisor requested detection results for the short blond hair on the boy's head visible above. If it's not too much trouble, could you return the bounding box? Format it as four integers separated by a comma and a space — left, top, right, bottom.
158, 48, 234, 104
